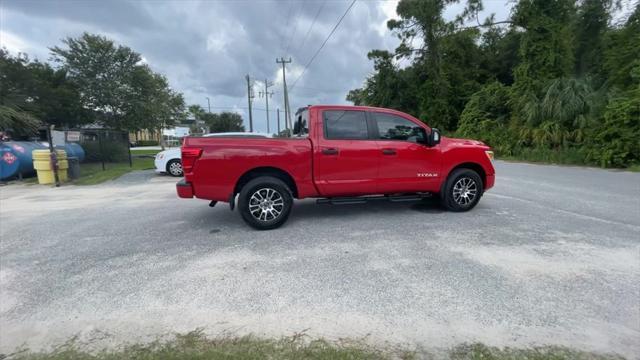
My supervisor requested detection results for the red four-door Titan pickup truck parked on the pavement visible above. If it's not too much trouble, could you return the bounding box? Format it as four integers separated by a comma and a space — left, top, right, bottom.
177, 105, 495, 229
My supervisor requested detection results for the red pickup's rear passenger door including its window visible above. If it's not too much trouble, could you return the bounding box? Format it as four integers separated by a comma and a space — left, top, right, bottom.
314, 110, 379, 197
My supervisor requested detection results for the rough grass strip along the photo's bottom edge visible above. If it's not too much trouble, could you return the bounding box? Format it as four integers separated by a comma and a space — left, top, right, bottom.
6, 330, 622, 360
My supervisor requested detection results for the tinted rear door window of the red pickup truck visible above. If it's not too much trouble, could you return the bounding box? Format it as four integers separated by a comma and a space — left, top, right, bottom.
323, 110, 369, 140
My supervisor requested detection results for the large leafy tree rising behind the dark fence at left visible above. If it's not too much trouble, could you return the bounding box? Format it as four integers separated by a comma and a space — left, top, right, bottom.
51, 33, 185, 131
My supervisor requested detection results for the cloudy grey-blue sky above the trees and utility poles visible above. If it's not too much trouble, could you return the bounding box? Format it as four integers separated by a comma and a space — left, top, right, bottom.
0, 0, 511, 132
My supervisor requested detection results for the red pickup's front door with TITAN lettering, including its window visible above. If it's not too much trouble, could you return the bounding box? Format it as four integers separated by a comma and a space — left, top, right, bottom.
369, 112, 440, 194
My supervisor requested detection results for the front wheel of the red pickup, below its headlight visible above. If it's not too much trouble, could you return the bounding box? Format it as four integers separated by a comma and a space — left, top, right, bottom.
440, 168, 484, 212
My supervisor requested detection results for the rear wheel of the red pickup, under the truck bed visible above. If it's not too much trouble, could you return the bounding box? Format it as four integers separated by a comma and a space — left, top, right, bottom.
238, 176, 293, 230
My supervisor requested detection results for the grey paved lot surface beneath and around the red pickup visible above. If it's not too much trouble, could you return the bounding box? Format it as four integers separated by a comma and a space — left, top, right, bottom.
0, 162, 640, 358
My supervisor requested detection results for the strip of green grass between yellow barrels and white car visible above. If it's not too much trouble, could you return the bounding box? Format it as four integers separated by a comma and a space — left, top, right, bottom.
71, 157, 154, 185
